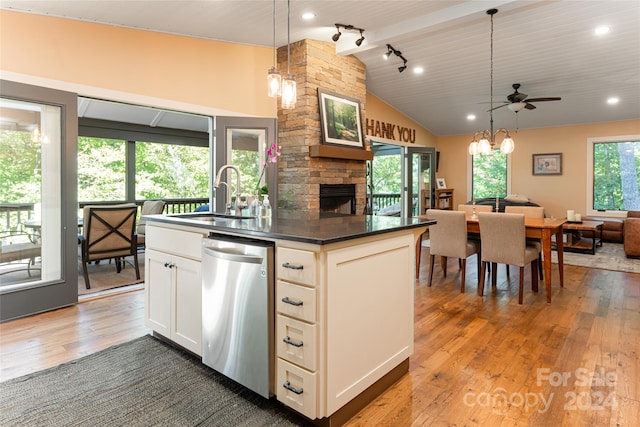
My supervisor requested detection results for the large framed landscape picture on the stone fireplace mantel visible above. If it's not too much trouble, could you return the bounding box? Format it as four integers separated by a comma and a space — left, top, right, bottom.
318, 88, 365, 150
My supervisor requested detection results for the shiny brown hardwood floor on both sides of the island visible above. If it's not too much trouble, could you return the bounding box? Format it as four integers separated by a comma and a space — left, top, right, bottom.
0, 253, 640, 426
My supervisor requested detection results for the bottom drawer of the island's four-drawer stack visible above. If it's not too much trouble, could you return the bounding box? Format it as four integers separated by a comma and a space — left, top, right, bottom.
276, 359, 317, 419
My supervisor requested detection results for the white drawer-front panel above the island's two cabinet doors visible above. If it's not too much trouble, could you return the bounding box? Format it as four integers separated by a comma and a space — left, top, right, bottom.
145, 223, 203, 259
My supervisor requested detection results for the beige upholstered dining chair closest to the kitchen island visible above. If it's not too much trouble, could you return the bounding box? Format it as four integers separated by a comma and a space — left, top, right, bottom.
427, 209, 480, 292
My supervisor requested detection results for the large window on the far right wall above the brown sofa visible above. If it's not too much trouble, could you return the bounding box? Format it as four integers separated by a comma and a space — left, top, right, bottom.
587, 135, 640, 216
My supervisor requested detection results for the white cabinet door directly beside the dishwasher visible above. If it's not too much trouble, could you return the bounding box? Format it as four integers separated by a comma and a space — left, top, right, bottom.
171, 257, 202, 355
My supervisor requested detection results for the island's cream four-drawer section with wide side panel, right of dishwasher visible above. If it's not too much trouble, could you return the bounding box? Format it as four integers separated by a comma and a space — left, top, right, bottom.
275, 231, 416, 419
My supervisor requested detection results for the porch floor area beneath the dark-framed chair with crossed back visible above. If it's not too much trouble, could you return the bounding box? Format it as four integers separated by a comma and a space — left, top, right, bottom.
78, 253, 144, 295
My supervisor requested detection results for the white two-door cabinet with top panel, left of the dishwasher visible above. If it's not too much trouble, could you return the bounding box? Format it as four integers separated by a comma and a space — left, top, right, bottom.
145, 225, 203, 355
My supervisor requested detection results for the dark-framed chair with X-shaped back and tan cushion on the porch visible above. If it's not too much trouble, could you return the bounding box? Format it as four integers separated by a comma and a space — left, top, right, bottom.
79, 203, 140, 289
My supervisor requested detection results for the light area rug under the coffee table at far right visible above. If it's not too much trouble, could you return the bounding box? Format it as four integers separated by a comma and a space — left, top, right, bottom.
551, 242, 640, 273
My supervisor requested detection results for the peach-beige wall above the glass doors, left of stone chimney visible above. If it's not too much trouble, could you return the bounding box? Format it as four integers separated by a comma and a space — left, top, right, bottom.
0, 10, 277, 117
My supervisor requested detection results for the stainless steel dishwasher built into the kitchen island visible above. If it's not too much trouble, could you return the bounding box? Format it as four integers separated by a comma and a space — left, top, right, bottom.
202, 233, 275, 398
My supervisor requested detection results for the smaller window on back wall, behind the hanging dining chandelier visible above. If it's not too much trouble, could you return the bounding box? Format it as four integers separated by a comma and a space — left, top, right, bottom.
471, 151, 508, 199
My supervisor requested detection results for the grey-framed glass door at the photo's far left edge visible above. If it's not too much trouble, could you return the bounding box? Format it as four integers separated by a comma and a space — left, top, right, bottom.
0, 81, 77, 320
